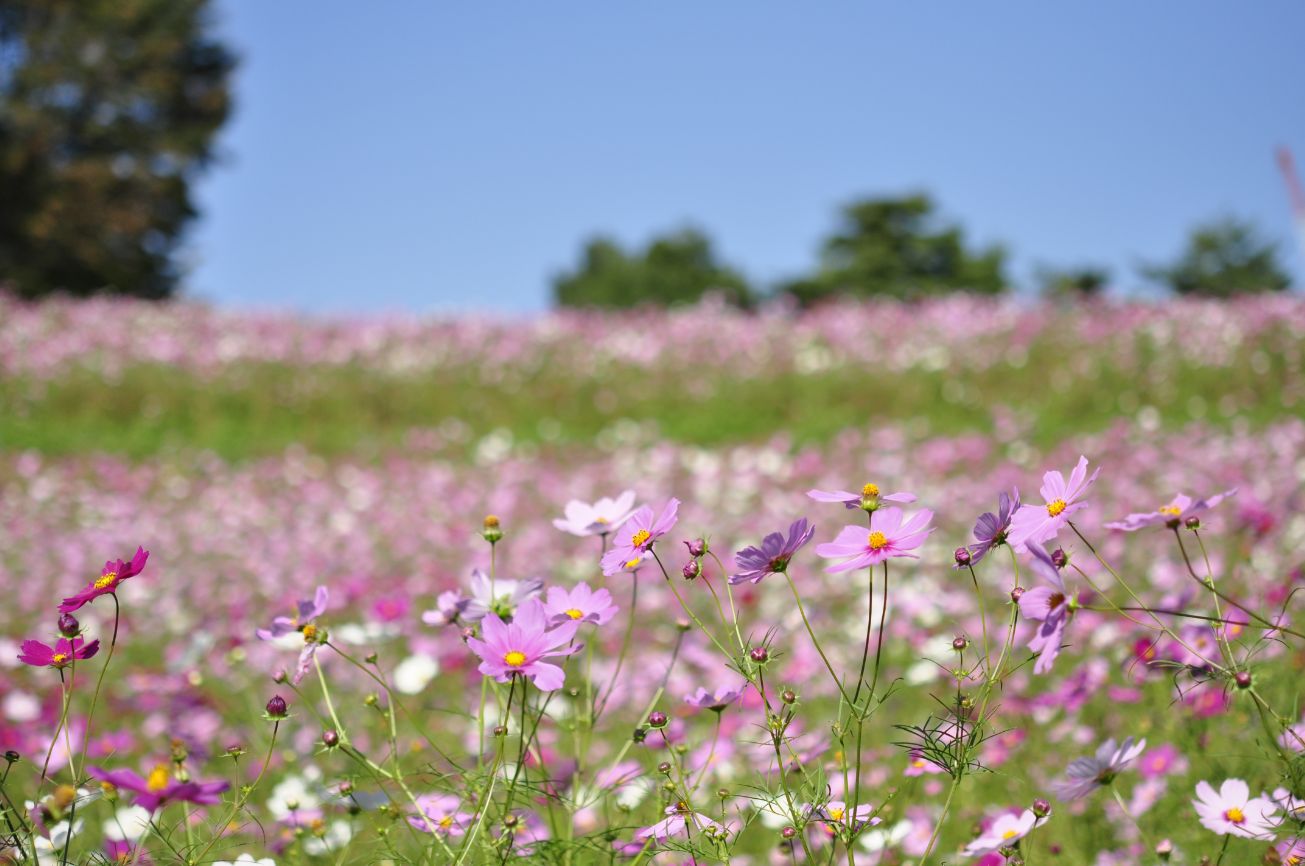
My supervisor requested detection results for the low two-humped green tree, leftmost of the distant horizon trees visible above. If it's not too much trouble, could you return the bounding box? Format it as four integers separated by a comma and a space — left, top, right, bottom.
553, 228, 752, 308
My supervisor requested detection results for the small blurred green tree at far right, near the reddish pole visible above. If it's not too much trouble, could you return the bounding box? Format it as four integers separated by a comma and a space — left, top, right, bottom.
1142, 217, 1292, 297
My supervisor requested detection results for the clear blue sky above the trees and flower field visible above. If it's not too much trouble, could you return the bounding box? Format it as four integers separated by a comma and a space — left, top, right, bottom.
189, 0, 1305, 312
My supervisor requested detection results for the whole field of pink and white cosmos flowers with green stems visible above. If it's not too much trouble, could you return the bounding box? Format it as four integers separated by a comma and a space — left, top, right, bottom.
0, 299, 1305, 866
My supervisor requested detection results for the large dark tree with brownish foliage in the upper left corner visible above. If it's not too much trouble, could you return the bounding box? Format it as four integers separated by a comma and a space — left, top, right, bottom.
0, 0, 235, 297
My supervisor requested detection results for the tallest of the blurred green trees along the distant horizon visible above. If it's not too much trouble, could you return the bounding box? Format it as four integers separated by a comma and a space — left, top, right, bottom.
784, 194, 1006, 304
